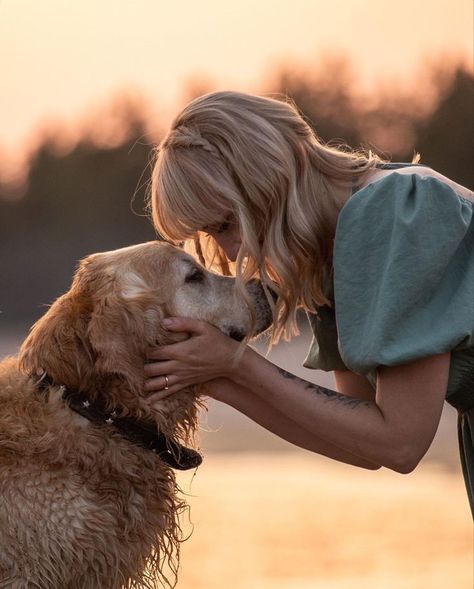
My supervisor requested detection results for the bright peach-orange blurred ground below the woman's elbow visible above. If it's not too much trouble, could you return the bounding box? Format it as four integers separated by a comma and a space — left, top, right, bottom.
178, 451, 473, 589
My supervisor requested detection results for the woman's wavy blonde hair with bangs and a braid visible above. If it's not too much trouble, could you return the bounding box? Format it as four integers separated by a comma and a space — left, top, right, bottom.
150, 91, 381, 341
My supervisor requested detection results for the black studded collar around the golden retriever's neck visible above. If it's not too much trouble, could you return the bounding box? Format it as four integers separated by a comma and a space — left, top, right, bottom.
32, 371, 202, 470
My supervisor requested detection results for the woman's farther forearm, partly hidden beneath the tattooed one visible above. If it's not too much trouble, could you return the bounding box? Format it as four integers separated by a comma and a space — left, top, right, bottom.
212, 379, 380, 470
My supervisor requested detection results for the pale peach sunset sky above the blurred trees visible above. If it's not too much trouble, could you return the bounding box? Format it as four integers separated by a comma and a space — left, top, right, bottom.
0, 0, 473, 170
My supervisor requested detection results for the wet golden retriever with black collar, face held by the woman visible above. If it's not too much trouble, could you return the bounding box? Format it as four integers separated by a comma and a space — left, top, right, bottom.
0, 242, 271, 589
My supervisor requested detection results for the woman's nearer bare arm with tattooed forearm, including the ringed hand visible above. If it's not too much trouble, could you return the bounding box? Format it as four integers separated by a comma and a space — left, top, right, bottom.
146, 318, 450, 472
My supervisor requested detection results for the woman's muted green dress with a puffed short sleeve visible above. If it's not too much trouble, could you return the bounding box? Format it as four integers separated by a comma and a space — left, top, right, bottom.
304, 164, 474, 513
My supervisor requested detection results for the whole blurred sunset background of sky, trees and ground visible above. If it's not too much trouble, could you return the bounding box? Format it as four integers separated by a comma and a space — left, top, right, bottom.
0, 0, 474, 589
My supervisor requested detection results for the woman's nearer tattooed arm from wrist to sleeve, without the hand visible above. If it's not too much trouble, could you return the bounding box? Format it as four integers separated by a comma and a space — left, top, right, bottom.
231, 348, 450, 473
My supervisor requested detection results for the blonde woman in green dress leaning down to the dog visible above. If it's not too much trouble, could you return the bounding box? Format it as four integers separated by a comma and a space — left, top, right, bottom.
145, 92, 474, 509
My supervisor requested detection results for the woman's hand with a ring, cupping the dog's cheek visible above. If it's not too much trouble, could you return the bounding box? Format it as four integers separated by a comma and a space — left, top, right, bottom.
145, 317, 239, 402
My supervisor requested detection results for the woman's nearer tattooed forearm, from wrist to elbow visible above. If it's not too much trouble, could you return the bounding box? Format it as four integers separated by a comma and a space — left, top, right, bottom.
229, 348, 448, 472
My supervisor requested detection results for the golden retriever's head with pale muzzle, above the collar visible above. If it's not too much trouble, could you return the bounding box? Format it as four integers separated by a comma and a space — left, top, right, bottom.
21, 242, 271, 434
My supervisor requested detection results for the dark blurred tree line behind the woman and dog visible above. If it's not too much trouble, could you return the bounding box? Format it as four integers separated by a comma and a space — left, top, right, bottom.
0, 59, 474, 326
